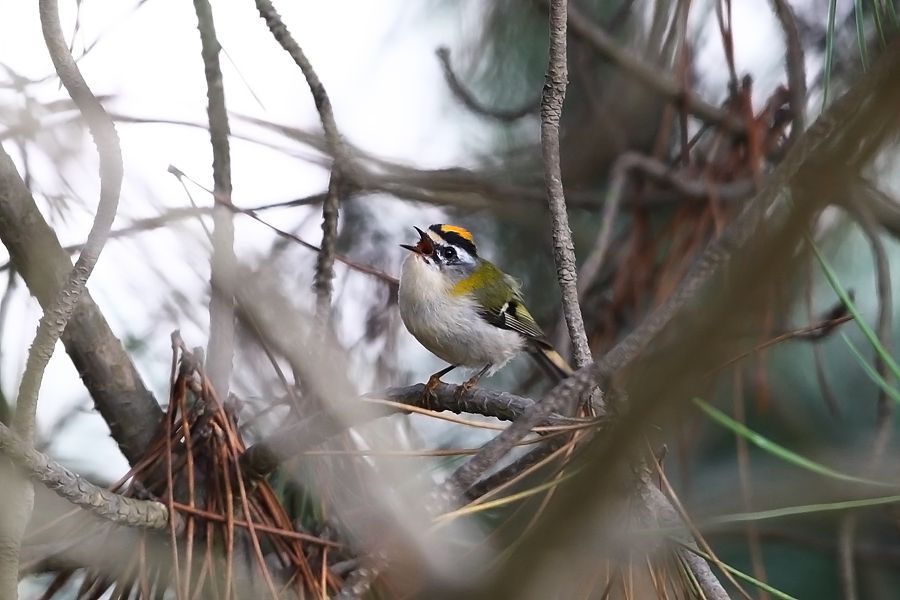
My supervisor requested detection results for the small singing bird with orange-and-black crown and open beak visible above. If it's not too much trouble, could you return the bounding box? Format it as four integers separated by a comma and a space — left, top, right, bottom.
398, 224, 572, 393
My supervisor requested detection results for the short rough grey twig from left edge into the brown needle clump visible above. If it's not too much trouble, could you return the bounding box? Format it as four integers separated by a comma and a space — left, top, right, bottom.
0, 423, 172, 529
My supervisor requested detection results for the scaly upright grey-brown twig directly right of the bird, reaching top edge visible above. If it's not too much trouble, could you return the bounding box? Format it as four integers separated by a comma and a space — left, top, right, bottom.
541, 0, 591, 367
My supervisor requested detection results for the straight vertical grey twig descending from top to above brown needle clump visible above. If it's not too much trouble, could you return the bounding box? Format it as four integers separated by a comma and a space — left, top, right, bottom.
194, 0, 235, 398
